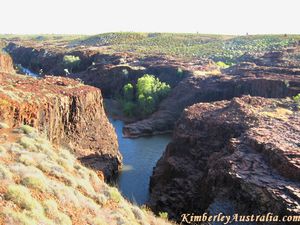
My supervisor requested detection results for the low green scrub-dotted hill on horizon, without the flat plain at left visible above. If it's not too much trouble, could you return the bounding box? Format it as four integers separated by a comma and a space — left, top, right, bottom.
70, 33, 300, 63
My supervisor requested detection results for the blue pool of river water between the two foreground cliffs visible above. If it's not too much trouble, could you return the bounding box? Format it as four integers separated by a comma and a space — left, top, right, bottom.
110, 119, 171, 205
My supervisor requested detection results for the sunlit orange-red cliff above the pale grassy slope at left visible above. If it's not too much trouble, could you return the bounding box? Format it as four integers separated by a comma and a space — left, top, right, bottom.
0, 73, 122, 180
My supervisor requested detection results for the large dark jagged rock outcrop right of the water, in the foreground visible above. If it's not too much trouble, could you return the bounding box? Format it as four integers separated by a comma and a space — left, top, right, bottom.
150, 96, 300, 220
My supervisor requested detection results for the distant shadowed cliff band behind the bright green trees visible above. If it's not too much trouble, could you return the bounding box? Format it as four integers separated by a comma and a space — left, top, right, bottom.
5, 43, 192, 97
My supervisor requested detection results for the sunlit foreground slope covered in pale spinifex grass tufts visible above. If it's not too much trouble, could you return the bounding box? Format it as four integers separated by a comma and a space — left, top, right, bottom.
0, 123, 170, 225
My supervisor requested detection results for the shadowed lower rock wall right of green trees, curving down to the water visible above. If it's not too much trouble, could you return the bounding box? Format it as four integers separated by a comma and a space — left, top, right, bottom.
123, 71, 300, 137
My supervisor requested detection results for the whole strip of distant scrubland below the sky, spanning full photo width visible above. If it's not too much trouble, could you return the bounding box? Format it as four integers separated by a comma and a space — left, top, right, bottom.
0, 32, 300, 64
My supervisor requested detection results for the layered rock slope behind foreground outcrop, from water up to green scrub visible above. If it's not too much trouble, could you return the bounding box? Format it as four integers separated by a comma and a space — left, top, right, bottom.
124, 48, 300, 137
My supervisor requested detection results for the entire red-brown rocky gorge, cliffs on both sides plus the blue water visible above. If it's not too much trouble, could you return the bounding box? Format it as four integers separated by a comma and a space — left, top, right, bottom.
0, 34, 300, 224
